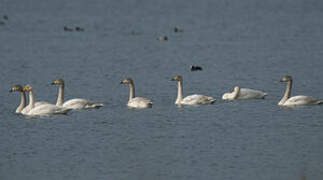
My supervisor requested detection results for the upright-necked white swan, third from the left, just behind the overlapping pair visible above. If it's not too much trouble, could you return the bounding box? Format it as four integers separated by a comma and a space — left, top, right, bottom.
52, 79, 103, 109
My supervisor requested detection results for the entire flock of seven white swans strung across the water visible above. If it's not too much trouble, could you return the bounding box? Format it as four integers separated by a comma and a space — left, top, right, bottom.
9, 75, 323, 116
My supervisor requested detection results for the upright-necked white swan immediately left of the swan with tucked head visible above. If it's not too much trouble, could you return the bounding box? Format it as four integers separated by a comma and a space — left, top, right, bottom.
172, 76, 216, 105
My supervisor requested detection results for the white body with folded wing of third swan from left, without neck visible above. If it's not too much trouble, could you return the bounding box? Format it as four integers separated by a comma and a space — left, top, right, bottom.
63, 98, 103, 109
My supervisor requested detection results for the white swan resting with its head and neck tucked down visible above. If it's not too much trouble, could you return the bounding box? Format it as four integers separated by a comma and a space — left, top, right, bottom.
222, 86, 267, 100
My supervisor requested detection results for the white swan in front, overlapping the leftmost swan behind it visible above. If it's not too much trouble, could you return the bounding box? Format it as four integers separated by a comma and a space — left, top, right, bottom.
21, 84, 71, 116
